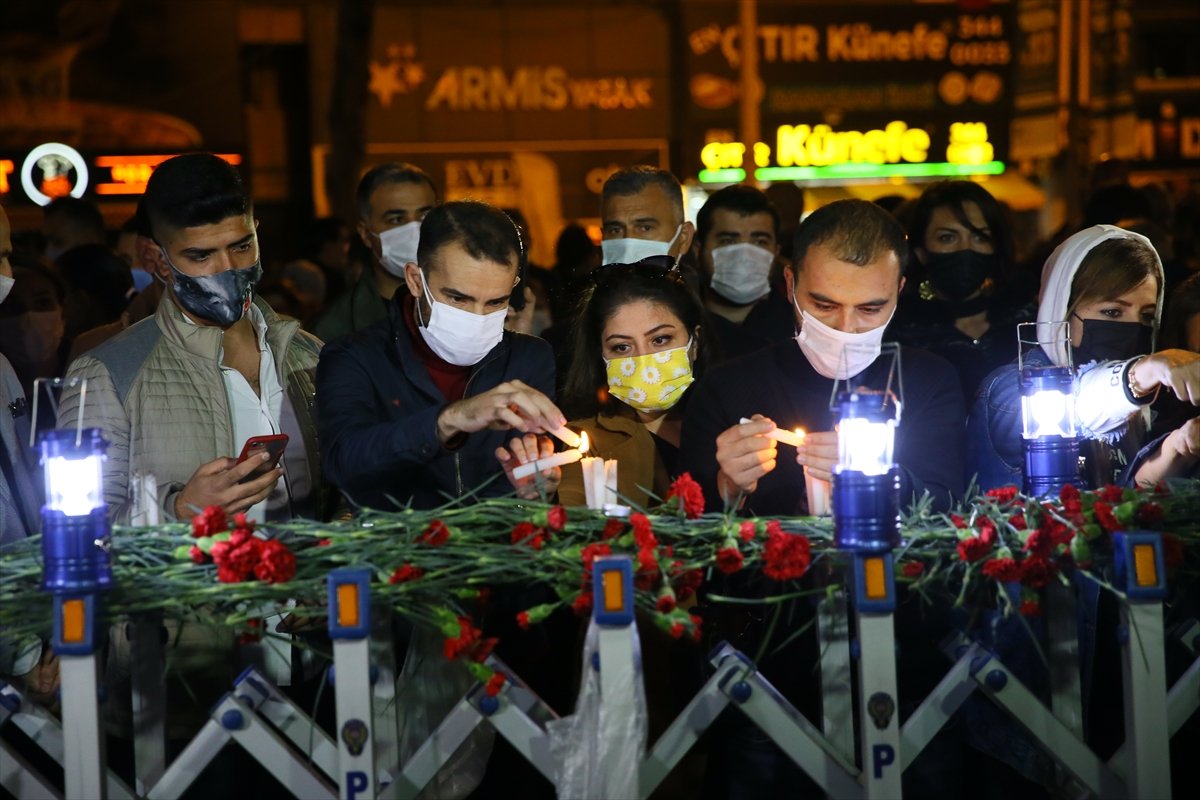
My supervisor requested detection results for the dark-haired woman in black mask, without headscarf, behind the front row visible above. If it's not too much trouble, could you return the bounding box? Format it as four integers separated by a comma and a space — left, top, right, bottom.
888, 181, 1034, 403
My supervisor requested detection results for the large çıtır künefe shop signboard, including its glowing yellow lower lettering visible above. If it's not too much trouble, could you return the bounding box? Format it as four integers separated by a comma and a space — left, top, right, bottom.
684, 0, 1016, 174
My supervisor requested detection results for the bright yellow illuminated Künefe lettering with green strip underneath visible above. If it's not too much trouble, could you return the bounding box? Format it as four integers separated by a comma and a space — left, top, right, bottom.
700, 120, 1004, 184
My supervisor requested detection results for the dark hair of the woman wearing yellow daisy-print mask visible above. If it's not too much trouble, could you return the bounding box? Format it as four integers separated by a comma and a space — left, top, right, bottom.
563, 263, 715, 417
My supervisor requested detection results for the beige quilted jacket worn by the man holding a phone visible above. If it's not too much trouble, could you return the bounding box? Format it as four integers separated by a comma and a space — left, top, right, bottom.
58, 295, 328, 523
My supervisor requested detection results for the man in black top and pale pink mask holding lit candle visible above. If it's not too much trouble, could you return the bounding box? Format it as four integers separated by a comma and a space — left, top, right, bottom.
682, 200, 965, 515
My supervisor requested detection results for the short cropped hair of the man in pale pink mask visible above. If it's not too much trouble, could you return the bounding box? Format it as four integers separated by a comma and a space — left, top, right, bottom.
792, 199, 908, 273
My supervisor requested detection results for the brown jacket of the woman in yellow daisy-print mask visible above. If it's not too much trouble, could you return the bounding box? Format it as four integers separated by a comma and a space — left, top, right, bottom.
558, 402, 671, 509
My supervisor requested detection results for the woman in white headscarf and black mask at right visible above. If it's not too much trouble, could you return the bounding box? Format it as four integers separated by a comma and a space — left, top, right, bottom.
967, 225, 1200, 489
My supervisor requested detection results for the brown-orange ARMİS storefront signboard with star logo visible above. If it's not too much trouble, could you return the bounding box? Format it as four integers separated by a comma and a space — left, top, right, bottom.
367, 5, 670, 143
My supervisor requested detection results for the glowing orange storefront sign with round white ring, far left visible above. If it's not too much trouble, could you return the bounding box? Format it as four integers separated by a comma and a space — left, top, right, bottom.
0, 148, 241, 205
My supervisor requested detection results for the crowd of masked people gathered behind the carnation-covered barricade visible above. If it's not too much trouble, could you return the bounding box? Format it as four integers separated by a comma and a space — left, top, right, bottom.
0, 154, 1200, 796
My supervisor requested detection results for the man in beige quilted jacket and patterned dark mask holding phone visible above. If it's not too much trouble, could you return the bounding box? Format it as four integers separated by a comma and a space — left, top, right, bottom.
59, 154, 331, 522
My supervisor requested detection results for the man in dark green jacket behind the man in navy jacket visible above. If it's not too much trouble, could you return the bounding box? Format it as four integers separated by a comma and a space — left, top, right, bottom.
312, 162, 438, 342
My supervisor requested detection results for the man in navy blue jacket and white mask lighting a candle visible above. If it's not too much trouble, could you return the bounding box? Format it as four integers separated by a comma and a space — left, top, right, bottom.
317, 201, 566, 509
